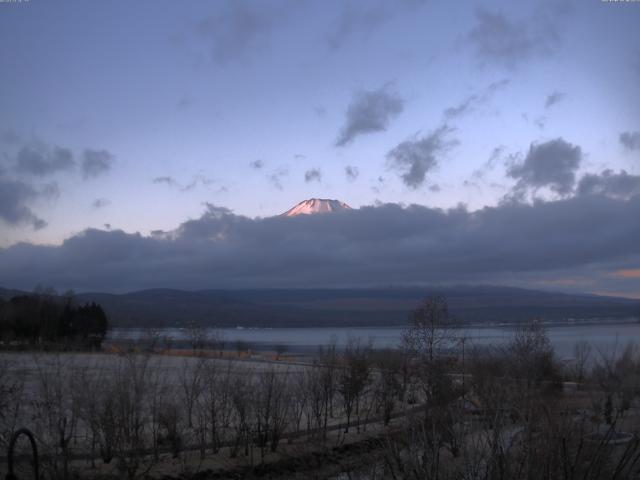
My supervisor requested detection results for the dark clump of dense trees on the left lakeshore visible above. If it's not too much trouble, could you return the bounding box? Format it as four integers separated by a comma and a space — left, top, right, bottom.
0, 289, 109, 348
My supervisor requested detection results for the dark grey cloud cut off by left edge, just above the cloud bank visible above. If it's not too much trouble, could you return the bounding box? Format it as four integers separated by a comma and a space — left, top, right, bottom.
0, 172, 47, 230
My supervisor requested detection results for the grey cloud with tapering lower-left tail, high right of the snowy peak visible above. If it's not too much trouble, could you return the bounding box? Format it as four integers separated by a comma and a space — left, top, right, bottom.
336, 84, 404, 147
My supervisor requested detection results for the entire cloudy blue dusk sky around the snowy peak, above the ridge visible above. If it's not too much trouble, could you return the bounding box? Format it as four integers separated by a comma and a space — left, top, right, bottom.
0, 0, 640, 298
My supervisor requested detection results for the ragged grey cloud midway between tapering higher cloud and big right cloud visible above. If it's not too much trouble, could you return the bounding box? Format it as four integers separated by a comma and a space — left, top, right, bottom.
387, 125, 458, 189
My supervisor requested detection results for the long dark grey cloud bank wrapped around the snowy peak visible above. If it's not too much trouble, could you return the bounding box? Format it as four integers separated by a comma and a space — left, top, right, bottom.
0, 188, 640, 291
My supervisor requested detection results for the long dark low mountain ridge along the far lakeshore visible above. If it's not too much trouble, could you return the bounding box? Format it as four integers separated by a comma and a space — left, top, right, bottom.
0, 286, 640, 327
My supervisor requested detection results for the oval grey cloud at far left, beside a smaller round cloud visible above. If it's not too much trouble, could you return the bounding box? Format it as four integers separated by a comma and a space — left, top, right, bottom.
16, 142, 76, 177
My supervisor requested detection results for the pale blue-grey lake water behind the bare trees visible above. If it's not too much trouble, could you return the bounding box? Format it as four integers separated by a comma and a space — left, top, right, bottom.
107, 322, 640, 358
